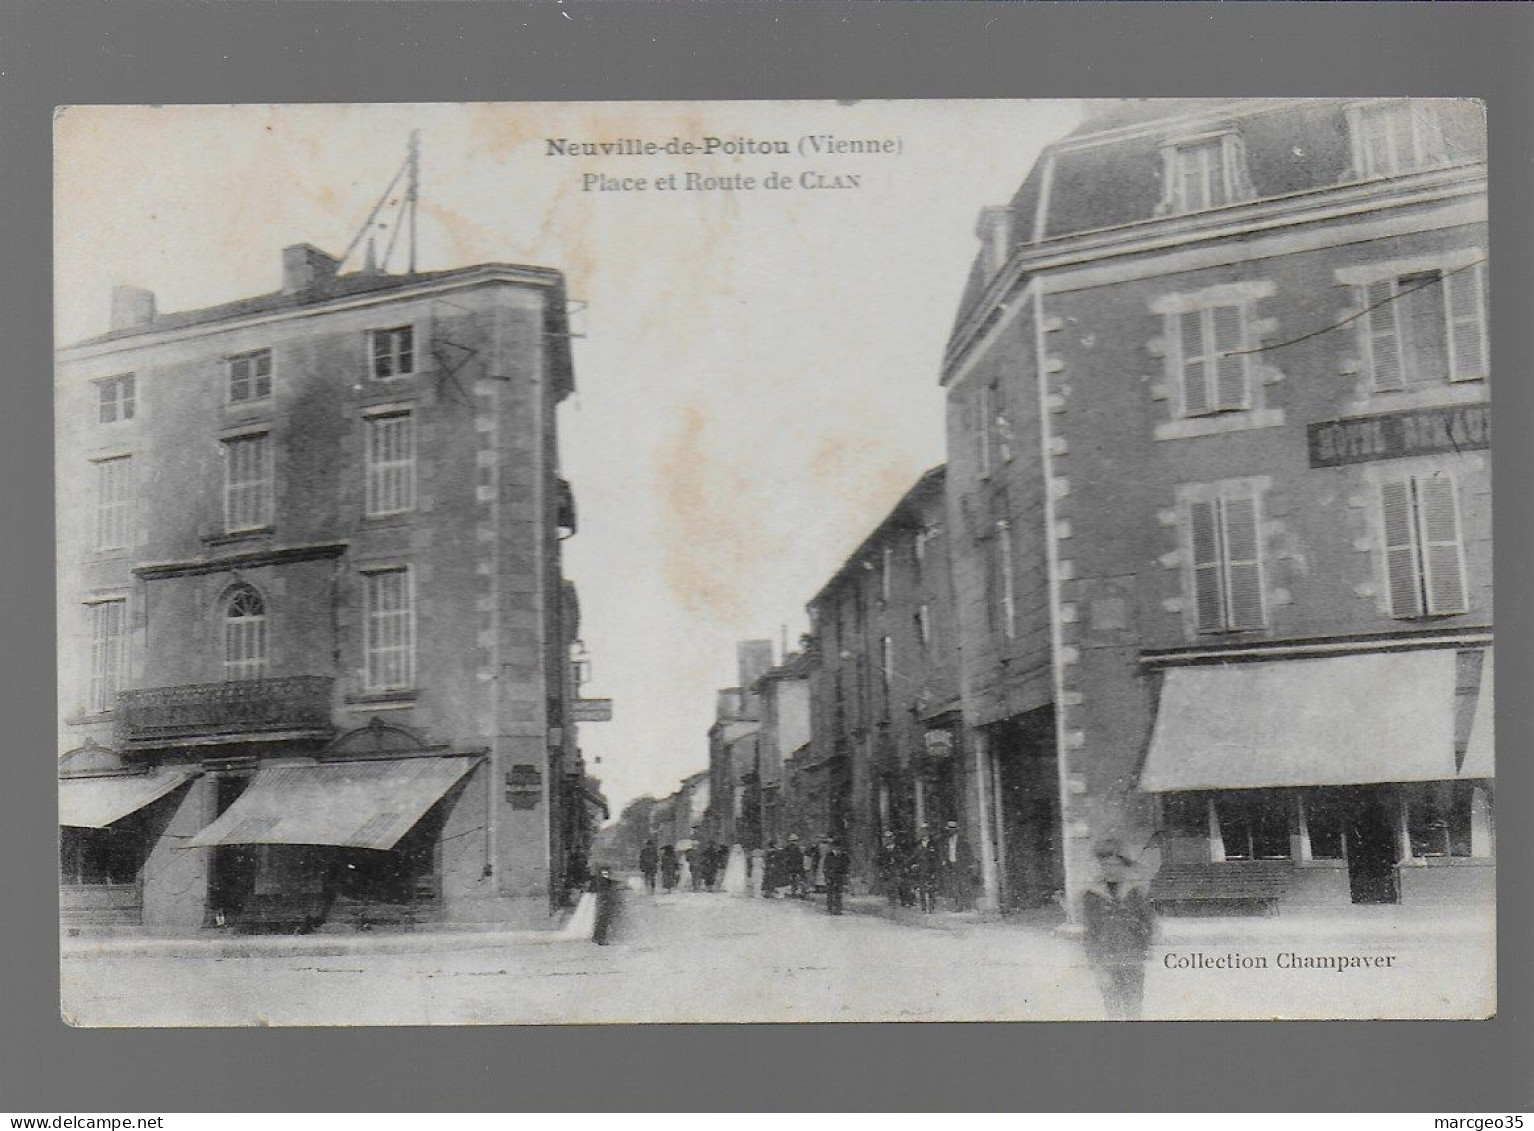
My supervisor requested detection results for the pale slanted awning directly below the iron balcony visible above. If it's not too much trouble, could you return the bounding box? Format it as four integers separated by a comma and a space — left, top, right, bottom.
186, 758, 479, 850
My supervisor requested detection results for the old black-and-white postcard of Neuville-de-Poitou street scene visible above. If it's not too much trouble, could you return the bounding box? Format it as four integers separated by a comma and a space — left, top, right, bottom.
55, 97, 1497, 1027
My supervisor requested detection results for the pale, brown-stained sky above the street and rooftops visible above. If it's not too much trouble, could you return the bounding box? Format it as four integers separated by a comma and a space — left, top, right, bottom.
55, 101, 1080, 816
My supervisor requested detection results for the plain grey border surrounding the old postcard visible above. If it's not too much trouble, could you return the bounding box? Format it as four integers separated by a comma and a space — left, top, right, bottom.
0, 0, 1534, 1114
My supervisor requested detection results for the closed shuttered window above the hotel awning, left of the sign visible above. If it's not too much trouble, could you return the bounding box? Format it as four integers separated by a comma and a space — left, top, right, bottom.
1187, 496, 1267, 632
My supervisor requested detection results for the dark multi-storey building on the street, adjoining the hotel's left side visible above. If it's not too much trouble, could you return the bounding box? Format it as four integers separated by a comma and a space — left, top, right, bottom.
795, 467, 957, 884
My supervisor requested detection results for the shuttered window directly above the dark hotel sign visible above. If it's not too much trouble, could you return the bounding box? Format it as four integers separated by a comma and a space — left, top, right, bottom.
1361, 264, 1488, 393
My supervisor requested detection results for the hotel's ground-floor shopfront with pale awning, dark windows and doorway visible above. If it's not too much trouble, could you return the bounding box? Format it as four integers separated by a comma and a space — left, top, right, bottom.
1140, 648, 1494, 913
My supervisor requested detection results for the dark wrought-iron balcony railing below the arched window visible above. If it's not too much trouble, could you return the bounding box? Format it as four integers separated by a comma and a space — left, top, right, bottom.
117, 675, 334, 746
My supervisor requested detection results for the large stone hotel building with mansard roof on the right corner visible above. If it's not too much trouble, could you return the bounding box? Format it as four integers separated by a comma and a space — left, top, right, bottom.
943, 98, 1493, 913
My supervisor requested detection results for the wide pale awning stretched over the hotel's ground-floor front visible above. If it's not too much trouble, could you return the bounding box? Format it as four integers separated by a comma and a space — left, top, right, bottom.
1140, 649, 1454, 793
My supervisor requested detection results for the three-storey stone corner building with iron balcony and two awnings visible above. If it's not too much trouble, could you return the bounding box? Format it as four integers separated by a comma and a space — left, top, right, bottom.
57, 246, 586, 930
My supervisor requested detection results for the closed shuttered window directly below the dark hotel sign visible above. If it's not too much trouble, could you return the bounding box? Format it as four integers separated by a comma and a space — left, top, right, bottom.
1379, 474, 1470, 618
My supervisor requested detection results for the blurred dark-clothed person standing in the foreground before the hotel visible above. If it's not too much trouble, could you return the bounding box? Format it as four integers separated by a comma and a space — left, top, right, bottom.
1081, 836, 1155, 1021
